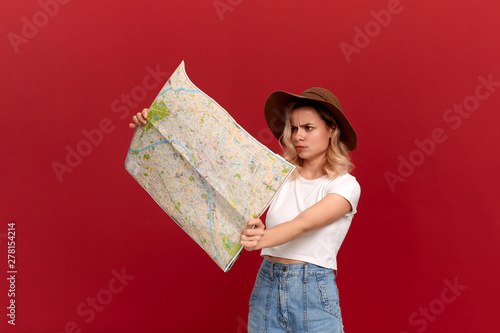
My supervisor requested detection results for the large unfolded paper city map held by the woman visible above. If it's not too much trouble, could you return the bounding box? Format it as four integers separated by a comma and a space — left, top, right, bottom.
125, 62, 294, 272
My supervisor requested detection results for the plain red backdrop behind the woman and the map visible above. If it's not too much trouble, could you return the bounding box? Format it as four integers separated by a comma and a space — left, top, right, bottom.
0, 0, 500, 333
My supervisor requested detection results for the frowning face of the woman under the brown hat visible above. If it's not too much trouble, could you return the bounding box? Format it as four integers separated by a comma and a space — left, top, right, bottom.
290, 106, 334, 161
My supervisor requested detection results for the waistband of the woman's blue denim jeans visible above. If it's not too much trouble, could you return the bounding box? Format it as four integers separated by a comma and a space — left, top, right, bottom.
261, 258, 337, 281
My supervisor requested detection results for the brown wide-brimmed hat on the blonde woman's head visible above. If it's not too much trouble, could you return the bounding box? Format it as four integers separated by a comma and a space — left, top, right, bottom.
264, 87, 358, 150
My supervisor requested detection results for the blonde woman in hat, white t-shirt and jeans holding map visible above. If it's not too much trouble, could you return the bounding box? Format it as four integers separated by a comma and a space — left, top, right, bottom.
241, 88, 360, 332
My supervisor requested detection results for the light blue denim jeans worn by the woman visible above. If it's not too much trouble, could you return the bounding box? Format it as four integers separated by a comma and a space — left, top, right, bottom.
248, 259, 344, 333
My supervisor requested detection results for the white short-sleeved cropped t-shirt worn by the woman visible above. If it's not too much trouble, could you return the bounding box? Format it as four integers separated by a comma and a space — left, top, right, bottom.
261, 174, 361, 269
